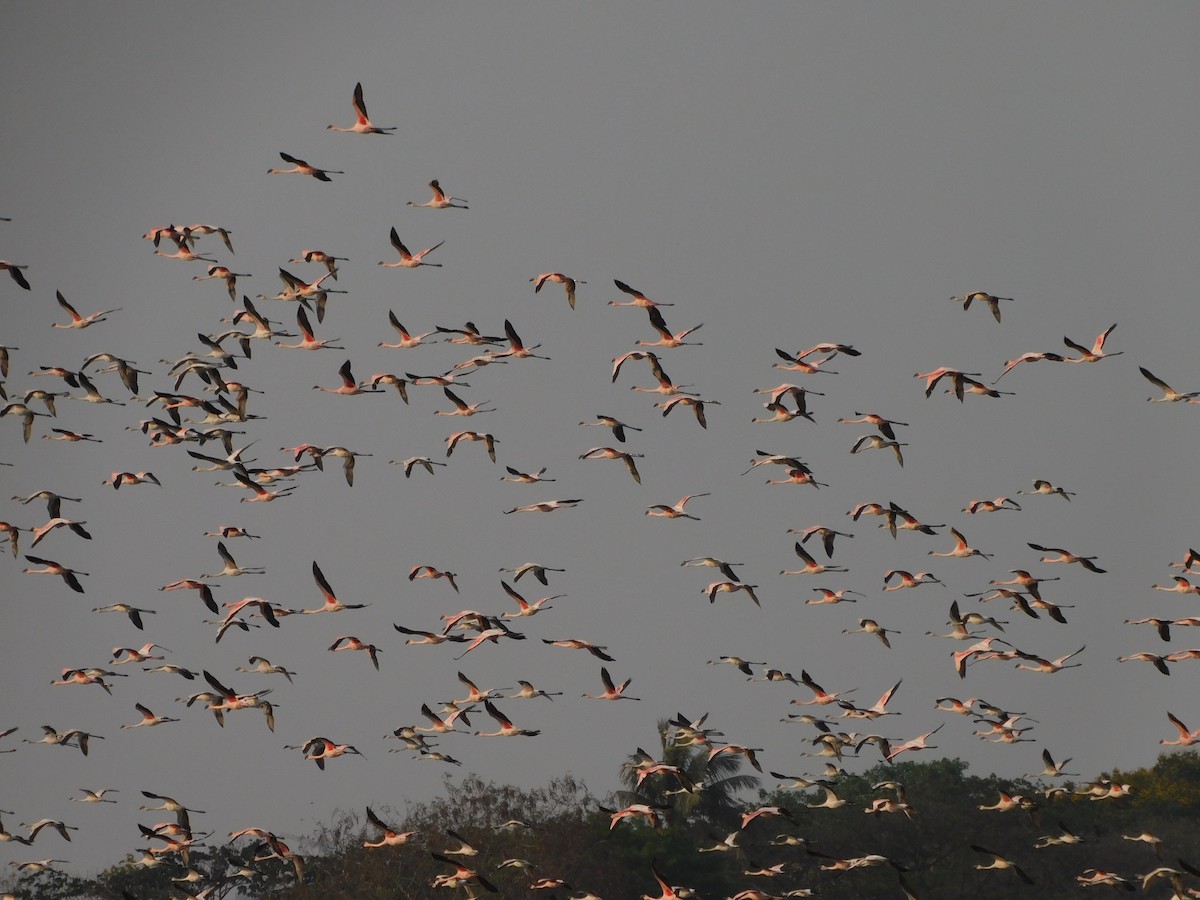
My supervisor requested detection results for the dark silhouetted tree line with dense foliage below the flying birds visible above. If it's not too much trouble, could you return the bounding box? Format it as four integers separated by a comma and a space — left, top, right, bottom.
8, 748, 1200, 900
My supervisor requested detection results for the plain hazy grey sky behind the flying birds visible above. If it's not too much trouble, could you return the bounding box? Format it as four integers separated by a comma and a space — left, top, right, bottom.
0, 1, 1200, 871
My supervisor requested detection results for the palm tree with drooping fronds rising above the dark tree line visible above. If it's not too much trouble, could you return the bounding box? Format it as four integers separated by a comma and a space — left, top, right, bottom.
617, 719, 758, 827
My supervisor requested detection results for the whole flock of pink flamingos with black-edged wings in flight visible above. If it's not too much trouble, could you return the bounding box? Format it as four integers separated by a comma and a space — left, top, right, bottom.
0, 84, 1200, 900
